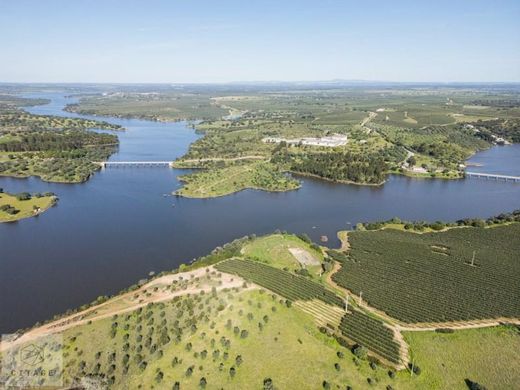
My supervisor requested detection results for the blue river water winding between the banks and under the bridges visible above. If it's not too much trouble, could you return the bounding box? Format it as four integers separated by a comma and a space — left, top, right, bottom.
0, 93, 520, 332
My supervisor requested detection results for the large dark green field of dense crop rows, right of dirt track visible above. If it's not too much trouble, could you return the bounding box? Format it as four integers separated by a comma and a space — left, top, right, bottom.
333, 224, 520, 323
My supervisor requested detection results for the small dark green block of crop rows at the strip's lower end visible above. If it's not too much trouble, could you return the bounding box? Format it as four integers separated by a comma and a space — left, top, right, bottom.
340, 310, 400, 364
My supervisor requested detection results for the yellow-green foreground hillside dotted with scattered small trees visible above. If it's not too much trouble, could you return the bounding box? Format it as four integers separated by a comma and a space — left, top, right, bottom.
1, 276, 410, 389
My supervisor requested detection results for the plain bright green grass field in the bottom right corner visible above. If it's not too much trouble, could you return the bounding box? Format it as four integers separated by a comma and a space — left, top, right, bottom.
397, 326, 520, 390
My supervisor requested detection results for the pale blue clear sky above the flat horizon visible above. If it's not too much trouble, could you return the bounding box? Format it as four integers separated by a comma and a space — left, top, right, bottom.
0, 0, 520, 83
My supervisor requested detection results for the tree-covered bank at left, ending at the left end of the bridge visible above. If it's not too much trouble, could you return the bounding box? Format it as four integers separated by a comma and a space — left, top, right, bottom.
0, 103, 122, 183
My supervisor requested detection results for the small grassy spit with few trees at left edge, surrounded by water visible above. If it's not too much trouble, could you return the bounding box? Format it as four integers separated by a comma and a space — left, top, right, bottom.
0, 188, 58, 223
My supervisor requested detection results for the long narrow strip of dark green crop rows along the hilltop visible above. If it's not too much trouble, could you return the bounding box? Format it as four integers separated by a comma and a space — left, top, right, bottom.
216, 259, 343, 307
